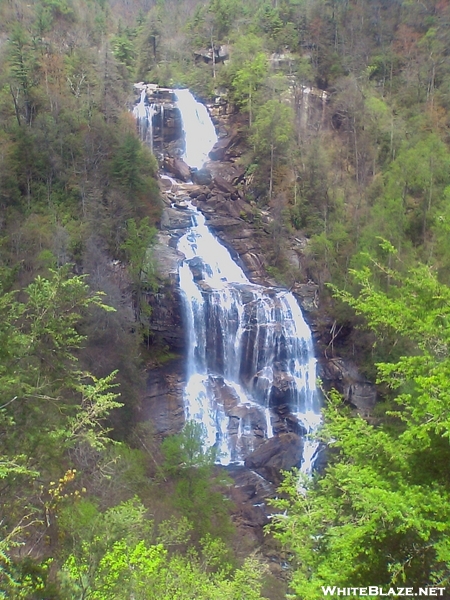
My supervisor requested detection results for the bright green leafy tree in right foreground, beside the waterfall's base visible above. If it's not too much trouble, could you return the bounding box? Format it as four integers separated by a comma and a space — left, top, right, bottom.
274, 243, 450, 600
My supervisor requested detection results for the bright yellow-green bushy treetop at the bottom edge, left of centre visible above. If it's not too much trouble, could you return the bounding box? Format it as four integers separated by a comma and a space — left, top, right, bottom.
59, 498, 270, 600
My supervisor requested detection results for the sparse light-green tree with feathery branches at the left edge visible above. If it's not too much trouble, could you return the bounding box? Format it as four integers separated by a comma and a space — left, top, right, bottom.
0, 267, 120, 598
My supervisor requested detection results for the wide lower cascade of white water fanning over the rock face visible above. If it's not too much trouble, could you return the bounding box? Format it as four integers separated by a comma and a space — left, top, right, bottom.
178, 212, 320, 472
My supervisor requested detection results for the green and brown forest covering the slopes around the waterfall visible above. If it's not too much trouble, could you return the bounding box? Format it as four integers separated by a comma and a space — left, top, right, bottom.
0, 0, 450, 600
